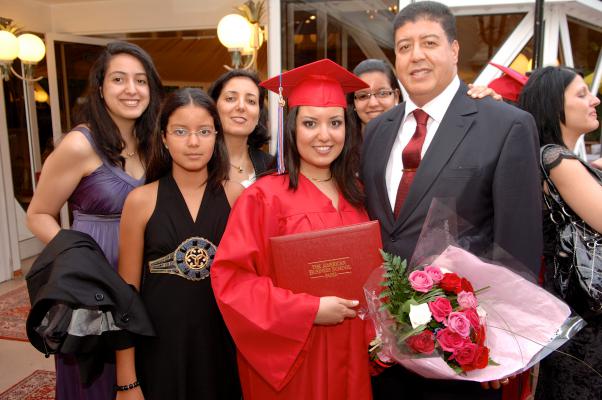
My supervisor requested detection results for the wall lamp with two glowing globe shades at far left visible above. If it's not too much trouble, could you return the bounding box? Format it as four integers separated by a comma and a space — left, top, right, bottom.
0, 17, 46, 82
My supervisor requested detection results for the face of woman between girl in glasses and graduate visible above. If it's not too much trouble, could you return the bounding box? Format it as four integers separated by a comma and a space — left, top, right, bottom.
216, 76, 260, 136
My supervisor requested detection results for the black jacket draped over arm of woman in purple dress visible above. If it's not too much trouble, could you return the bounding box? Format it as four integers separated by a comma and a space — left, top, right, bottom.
25, 229, 155, 384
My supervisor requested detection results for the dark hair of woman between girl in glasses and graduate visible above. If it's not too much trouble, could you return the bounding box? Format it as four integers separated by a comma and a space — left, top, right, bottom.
207, 69, 270, 149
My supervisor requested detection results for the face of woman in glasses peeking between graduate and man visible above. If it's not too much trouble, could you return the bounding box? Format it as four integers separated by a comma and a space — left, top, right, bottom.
354, 71, 399, 124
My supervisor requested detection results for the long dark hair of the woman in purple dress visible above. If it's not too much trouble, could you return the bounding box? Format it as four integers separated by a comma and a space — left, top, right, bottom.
74, 41, 163, 168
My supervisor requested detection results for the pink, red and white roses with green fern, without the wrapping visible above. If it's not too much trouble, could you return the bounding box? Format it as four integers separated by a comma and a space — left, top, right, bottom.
379, 252, 497, 373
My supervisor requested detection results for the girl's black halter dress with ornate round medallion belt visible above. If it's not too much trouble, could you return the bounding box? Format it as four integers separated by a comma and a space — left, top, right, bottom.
136, 174, 241, 400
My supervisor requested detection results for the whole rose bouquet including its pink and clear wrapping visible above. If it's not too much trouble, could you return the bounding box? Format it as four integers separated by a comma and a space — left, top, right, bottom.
364, 200, 584, 382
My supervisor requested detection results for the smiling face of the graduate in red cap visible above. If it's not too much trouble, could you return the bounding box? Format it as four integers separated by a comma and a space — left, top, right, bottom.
295, 106, 345, 178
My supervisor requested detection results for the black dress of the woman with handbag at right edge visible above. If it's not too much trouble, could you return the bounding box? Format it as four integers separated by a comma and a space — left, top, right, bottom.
535, 146, 602, 400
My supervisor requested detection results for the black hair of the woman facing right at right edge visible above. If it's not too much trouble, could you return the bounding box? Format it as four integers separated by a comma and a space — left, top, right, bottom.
518, 67, 579, 147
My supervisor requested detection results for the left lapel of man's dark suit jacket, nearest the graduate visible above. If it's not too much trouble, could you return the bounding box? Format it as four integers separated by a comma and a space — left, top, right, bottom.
373, 103, 405, 232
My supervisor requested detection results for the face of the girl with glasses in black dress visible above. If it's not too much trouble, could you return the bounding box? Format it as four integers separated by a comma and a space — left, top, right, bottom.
163, 104, 215, 172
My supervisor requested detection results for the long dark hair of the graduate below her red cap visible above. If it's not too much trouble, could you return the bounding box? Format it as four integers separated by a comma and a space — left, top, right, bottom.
284, 106, 364, 207
